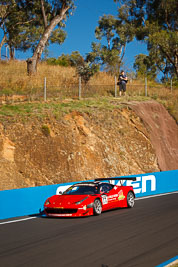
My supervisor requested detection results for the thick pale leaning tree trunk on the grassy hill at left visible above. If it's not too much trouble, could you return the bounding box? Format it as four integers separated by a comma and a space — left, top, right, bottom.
27, 6, 70, 75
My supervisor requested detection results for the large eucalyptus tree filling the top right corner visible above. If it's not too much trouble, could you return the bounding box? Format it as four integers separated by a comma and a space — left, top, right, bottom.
114, 0, 178, 76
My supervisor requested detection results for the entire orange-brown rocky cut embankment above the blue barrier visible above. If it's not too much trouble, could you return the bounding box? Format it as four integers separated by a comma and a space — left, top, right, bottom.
0, 102, 178, 190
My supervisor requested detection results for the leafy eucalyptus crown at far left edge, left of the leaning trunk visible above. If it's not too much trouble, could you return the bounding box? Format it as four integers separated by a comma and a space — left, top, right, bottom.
0, 0, 42, 59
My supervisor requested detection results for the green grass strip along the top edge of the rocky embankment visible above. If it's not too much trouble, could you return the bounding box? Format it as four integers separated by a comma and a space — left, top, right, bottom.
0, 95, 178, 122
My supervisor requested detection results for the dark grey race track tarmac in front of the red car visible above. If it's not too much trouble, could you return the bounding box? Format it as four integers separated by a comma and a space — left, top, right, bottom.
0, 193, 178, 267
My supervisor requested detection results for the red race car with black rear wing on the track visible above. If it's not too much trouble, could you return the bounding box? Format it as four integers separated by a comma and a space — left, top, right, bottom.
44, 177, 136, 217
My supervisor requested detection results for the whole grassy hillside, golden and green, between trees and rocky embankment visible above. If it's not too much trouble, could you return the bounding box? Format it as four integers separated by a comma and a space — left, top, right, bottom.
0, 61, 178, 121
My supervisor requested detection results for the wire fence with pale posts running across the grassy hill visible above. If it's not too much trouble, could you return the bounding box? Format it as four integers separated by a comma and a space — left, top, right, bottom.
0, 77, 174, 104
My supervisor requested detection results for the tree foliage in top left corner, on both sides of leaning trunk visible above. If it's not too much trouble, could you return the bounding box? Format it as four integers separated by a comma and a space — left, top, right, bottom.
0, 0, 74, 58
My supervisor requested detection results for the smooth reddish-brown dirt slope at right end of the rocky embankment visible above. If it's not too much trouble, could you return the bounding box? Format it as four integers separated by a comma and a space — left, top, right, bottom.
130, 101, 178, 171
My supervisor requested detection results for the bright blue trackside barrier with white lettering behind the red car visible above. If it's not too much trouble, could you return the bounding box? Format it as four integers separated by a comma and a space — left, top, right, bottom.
0, 170, 178, 219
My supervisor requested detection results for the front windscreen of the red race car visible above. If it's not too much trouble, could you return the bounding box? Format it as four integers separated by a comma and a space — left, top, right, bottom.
63, 185, 98, 195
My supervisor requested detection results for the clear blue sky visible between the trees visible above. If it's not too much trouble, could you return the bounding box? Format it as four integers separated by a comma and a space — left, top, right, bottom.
0, 0, 147, 70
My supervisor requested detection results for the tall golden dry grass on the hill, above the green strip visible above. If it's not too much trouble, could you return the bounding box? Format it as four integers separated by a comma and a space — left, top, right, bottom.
0, 61, 178, 121
